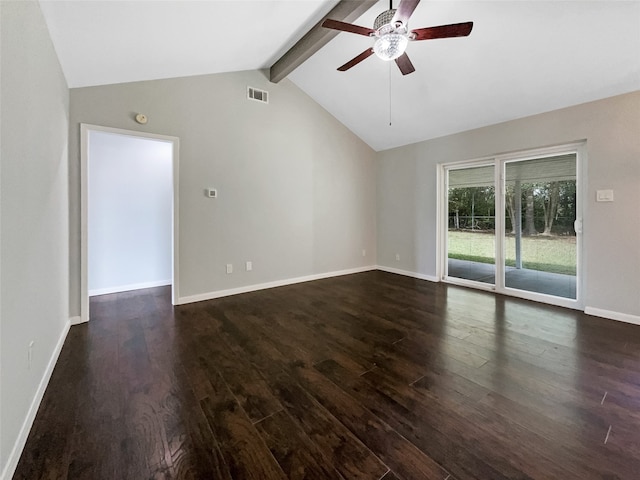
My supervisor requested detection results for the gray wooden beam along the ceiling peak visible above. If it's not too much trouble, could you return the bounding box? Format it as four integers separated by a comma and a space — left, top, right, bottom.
269, 0, 378, 83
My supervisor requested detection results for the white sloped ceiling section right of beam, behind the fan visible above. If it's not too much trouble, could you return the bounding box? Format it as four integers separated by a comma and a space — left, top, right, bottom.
289, 0, 640, 150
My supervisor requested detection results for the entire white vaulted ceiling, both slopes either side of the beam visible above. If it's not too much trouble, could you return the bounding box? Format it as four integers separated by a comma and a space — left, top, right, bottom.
40, 0, 640, 150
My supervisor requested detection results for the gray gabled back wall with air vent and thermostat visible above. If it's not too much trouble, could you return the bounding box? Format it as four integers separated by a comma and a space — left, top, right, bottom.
69, 71, 376, 315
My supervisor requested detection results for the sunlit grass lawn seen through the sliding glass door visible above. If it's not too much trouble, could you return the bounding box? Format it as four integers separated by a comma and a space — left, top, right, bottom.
449, 230, 576, 275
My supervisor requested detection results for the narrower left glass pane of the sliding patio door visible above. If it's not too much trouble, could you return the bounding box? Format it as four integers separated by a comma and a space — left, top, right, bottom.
447, 165, 496, 285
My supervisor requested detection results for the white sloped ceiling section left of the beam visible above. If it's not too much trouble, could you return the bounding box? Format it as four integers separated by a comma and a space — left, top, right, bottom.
40, 0, 338, 88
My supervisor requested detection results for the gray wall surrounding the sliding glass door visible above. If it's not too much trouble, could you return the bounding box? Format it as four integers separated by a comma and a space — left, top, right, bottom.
377, 92, 640, 316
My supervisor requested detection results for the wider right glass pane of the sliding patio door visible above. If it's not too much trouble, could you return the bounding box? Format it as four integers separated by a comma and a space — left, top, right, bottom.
504, 153, 577, 299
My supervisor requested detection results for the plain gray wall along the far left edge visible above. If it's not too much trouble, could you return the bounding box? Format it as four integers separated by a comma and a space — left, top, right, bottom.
0, 1, 69, 476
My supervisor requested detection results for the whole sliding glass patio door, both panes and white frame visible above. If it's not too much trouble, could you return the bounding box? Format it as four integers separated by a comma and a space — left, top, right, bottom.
441, 146, 581, 306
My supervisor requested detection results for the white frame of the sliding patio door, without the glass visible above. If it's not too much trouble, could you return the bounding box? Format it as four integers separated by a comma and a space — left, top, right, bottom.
437, 141, 587, 310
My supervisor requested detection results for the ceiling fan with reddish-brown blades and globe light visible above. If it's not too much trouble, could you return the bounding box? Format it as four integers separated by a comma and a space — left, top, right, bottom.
322, 0, 473, 75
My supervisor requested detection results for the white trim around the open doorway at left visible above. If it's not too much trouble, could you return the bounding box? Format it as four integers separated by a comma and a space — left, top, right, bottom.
80, 123, 180, 322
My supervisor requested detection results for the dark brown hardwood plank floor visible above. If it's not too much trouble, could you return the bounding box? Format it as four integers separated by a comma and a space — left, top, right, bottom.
14, 272, 640, 480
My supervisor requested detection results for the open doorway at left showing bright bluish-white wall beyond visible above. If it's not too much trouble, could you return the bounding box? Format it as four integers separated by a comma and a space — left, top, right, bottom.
81, 125, 178, 321
